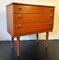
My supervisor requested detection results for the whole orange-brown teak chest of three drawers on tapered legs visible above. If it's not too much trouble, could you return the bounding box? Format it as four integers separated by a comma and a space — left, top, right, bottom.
7, 3, 55, 56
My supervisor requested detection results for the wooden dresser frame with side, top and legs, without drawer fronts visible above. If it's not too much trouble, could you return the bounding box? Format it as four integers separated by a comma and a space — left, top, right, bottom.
6, 3, 55, 56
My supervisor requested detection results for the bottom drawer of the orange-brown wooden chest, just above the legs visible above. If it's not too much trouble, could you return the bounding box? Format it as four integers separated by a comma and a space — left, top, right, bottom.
14, 22, 53, 34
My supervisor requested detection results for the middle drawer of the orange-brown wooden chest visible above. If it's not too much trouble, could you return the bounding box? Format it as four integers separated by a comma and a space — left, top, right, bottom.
14, 14, 53, 23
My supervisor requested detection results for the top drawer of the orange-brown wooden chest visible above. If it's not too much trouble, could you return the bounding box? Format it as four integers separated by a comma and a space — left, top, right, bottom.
13, 5, 54, 13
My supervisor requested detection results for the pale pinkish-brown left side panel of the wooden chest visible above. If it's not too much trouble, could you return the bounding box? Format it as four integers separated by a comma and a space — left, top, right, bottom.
6, 5, 13, 36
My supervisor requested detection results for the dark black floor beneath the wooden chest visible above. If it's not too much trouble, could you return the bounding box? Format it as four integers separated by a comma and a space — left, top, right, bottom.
0, 40, 59, 60
